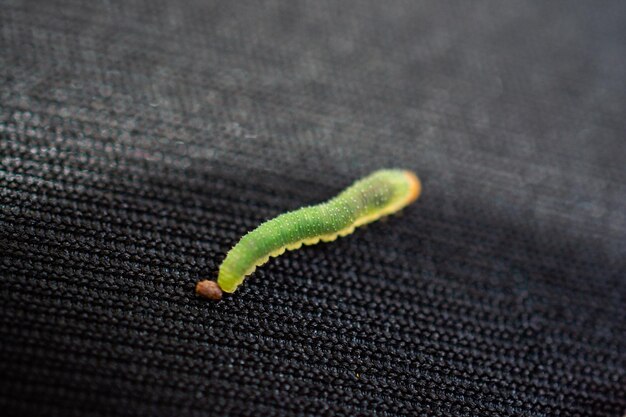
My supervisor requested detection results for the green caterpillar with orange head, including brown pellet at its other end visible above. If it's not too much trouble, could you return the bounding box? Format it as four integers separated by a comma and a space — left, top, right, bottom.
196, 169, 421, 300
